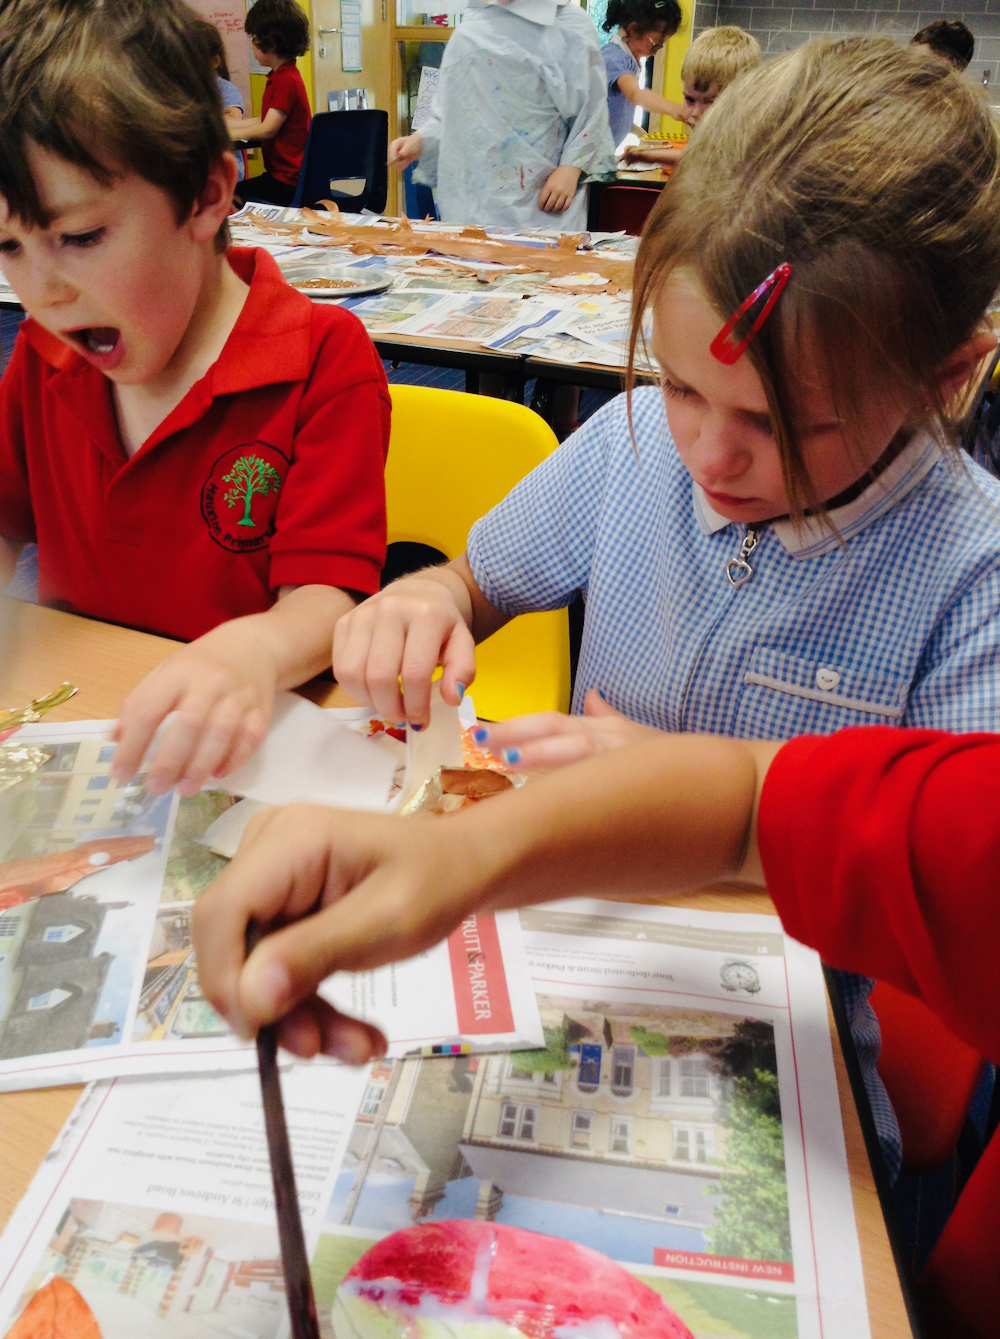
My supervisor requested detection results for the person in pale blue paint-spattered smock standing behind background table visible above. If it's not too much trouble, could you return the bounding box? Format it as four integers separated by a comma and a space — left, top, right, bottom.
388, 0, 614, 232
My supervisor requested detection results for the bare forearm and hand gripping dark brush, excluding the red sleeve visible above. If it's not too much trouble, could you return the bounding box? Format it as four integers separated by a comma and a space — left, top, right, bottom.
194, 735, 778, 1062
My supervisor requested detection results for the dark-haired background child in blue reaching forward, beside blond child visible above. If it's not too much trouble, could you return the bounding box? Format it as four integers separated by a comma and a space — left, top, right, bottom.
601, 0, 684, 145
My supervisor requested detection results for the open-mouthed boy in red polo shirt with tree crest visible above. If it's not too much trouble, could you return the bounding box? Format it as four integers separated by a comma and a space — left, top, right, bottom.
0, 0, 390, 794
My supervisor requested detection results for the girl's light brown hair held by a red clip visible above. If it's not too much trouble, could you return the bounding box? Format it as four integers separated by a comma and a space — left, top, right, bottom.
629, 37, 1000, 518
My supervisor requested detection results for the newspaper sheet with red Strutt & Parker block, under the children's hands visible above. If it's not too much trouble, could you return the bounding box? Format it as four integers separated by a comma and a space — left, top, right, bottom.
0, 723, 542, 1091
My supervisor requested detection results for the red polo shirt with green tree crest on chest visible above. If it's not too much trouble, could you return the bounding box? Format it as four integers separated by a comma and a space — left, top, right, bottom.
0, 249, 390, 640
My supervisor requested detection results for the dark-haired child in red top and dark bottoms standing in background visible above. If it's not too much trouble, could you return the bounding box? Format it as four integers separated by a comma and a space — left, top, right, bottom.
228, 0, 312, 205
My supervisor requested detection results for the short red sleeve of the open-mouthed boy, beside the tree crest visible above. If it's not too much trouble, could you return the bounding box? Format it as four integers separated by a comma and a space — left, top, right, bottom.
269, 304, 391, 595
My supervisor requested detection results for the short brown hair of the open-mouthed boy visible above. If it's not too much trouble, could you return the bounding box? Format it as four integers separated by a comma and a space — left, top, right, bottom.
0, 0, 232, 250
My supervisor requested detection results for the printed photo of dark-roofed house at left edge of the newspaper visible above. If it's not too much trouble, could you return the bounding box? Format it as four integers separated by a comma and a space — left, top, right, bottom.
0, 739, 171, 1060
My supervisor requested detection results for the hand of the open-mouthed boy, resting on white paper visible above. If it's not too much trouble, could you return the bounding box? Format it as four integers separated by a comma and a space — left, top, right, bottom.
111, 628, 277, 795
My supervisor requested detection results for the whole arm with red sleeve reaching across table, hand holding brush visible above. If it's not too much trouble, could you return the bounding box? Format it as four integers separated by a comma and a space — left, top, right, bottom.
195, 728, 1000, 1058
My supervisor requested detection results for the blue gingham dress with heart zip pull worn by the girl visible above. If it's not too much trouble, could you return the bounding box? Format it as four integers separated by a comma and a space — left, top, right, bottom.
469, 387, 1000, 1177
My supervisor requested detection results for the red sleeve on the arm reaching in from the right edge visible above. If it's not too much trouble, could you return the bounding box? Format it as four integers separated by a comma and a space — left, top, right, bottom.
759, 727, 1000, 1059
